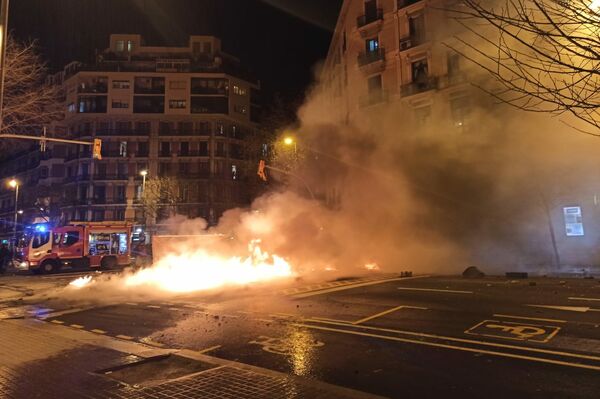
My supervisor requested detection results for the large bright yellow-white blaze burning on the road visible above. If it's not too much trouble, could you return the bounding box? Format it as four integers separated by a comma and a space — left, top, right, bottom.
125, 240, 293, 293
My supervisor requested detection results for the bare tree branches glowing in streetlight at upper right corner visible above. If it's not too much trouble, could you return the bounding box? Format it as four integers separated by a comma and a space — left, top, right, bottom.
450, 0, 600, 136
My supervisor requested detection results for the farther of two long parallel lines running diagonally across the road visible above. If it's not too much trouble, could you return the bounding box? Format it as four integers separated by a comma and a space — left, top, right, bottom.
305, 319, 600, 361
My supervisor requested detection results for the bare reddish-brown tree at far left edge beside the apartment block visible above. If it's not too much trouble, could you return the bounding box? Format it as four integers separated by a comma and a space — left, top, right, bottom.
1, 38, 63, 133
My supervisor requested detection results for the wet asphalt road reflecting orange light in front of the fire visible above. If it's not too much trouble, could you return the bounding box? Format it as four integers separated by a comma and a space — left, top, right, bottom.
0, 276, 600, 398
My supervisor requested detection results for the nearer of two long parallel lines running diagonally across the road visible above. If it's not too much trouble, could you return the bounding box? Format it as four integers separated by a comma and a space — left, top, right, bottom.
293, 324, 600, 371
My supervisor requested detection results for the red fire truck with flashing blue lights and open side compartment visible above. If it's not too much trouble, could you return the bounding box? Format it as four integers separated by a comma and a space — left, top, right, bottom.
18, 222, 132, 273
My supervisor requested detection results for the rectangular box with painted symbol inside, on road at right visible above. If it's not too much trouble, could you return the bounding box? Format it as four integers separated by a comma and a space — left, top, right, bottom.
465, 320, 560, 343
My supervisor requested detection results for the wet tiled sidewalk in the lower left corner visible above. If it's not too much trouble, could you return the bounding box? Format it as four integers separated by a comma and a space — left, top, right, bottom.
0, 319, 384, 399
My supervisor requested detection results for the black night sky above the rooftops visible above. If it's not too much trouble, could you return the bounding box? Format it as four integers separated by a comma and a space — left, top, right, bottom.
9, 0, 342, 104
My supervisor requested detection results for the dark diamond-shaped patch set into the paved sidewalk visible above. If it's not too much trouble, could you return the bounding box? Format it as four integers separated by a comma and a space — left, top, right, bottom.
98, 355, 217, 387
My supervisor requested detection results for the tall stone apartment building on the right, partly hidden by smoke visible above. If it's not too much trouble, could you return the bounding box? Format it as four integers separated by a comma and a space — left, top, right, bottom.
321, 0, 600, 267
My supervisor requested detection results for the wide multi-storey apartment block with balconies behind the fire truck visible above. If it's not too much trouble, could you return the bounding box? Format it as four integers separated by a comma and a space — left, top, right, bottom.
0, 34, 260, 241
